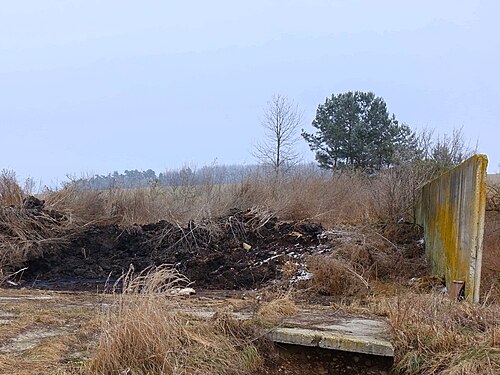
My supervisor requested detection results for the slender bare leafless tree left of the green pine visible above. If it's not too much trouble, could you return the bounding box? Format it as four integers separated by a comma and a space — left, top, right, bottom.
252, 94, 302, 177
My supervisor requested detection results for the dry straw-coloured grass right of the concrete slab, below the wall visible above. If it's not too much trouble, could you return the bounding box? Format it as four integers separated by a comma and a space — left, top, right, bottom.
387, 294, 500, 375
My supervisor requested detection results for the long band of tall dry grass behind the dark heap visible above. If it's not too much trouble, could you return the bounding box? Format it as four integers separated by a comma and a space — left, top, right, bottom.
43, 170, 422, 226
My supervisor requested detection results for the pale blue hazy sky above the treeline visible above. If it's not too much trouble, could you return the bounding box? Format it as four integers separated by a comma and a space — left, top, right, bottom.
0, 0, 500, 184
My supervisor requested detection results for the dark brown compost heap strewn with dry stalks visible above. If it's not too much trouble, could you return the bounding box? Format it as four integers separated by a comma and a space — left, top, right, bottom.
11, 204, 323, 289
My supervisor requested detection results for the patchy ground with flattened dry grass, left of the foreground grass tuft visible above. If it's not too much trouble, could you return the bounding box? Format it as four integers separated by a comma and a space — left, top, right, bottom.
0, 289, 103, 375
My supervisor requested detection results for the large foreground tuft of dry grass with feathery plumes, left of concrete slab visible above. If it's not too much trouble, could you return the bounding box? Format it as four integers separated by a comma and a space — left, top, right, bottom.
88, 267, 262, 374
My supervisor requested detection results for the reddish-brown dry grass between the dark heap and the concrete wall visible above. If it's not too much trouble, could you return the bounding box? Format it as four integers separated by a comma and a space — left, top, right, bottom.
307, 223, 427, 296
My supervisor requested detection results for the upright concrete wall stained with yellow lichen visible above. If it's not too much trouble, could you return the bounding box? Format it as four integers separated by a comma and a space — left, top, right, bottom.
416, 155, 488, 302
